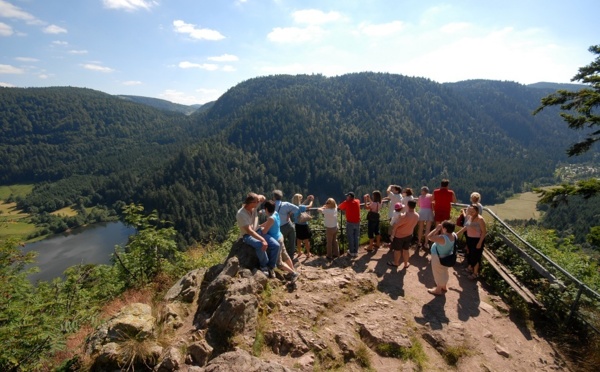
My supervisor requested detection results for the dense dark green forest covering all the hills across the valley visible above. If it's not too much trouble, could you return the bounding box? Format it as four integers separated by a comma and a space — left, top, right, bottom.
0, 73, 593, 243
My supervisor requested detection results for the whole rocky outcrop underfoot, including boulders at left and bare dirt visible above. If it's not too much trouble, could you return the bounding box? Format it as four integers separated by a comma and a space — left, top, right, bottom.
87, 243, 576, 371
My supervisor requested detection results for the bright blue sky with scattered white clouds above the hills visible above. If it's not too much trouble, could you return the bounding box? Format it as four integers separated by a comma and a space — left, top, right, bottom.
0, 0, 600, 105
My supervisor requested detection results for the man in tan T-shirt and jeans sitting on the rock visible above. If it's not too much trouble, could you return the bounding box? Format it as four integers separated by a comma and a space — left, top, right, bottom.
235, 192, 280, 278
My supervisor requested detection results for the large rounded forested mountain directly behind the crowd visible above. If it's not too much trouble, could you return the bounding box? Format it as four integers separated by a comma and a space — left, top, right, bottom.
132, 73, 574, 243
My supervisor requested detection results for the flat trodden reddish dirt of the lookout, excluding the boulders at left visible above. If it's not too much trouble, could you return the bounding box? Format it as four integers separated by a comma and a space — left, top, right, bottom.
261, 247, 568, 371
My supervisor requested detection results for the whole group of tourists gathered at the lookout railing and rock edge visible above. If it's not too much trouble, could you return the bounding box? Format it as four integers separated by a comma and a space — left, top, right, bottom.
236, 179, 487, 295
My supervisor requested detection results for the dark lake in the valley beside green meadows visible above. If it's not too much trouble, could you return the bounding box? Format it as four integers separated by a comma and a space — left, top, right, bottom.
23, 222, 135, 282
